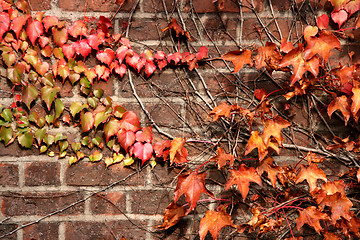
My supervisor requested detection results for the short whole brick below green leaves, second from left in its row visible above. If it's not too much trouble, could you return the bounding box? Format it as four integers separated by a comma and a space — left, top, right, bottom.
25, 162, 60, 186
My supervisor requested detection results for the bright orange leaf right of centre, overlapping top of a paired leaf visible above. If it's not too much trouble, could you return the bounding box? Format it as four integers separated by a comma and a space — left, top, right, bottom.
261, 115, 291, 145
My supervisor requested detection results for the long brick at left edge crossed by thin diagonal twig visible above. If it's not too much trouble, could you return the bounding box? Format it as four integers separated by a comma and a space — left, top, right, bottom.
1, 192, 84, 216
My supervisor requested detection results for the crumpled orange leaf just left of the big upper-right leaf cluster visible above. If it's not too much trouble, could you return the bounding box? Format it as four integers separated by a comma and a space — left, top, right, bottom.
255, 42, 282, 70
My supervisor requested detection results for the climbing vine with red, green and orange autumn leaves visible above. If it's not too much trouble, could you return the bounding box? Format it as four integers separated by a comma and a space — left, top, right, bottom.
0, 0, 360, 240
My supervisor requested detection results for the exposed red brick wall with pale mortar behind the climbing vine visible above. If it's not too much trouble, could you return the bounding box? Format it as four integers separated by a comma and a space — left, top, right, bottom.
0, 0, 354, 240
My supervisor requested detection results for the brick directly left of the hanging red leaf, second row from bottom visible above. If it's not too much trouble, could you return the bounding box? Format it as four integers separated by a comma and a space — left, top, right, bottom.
130, 190, 173, 215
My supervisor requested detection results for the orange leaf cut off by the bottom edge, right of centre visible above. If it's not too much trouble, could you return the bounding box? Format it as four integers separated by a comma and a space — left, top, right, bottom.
199, 210, 236, 240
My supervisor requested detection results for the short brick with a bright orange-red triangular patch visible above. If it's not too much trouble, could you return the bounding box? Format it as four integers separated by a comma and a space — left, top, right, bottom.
90, 192, 126, 214
